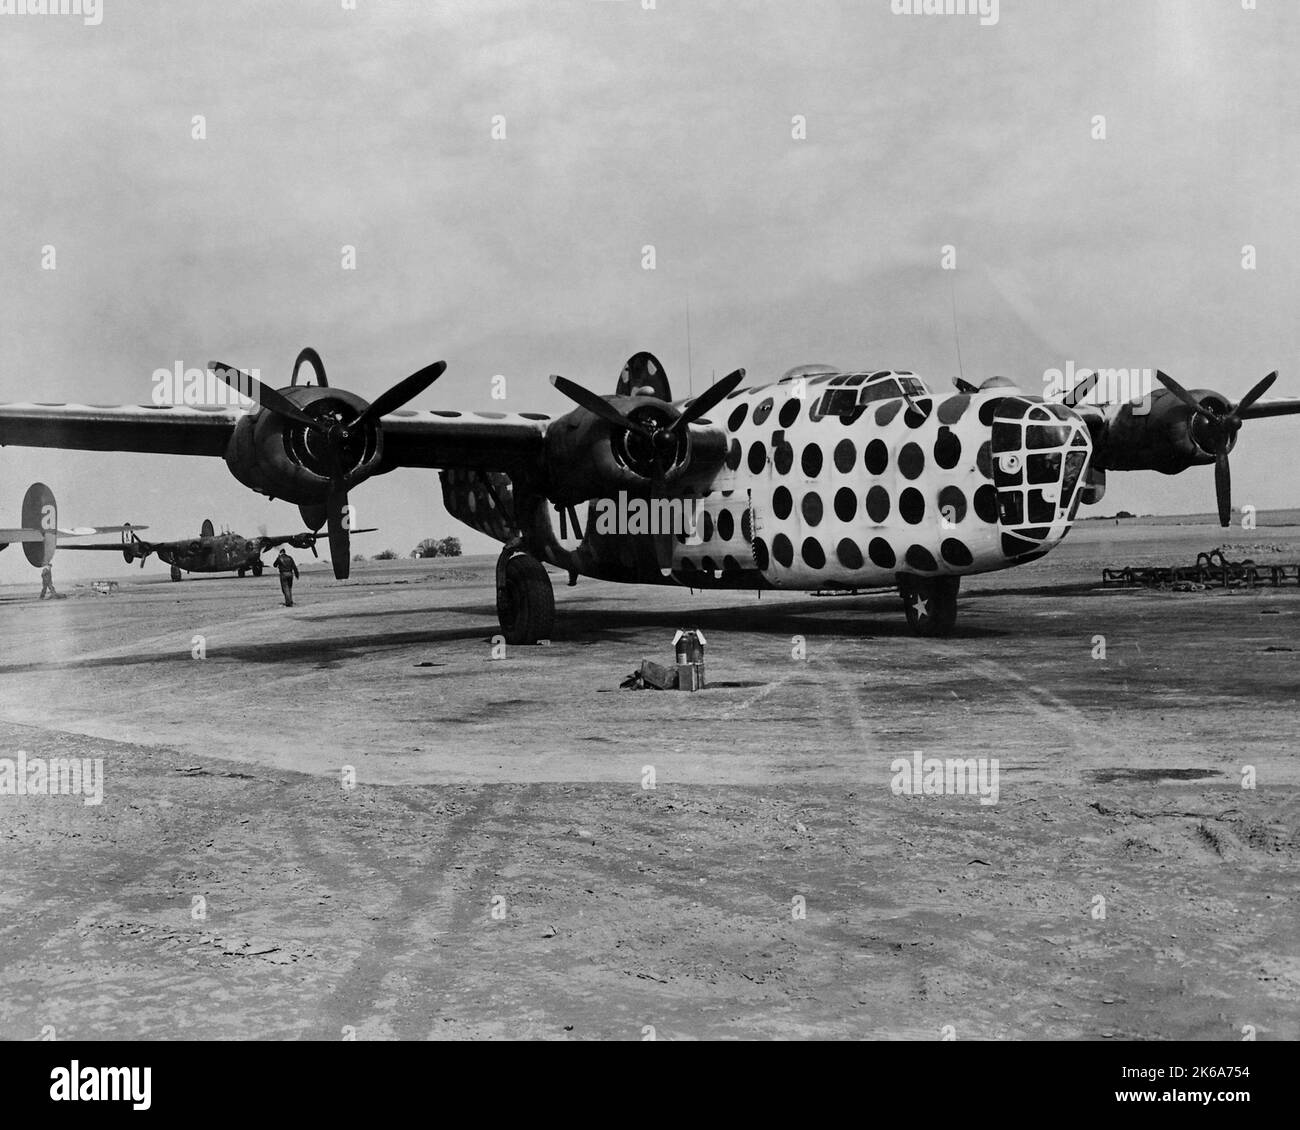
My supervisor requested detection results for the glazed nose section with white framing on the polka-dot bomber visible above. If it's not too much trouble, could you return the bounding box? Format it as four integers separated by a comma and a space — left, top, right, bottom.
992, 397, 1092, 558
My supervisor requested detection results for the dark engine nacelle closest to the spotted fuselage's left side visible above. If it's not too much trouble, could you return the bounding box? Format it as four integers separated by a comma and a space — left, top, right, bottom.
546, 397, 727, 506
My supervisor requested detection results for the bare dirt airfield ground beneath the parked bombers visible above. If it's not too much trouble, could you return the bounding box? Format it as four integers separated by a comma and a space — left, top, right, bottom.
0, 525, 1300, 1040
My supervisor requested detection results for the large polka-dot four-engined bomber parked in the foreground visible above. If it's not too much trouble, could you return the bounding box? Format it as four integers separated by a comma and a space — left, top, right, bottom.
0, 348, 1300, 644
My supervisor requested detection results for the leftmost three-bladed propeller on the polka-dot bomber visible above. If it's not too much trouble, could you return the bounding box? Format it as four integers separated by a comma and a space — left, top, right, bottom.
208, 350, 447, 581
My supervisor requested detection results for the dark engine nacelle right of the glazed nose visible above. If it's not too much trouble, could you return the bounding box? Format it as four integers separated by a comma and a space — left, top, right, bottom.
1096, 389, 1236, 475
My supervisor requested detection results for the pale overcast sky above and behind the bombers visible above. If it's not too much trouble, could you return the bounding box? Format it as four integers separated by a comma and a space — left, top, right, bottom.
0, 0, 1300, 581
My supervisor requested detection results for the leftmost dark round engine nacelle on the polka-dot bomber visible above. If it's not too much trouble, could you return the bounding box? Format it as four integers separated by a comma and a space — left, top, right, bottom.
225, 385, 384, 505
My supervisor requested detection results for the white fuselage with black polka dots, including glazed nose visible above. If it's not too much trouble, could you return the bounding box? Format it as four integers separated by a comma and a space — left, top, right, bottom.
443, 371, 1092, 590
